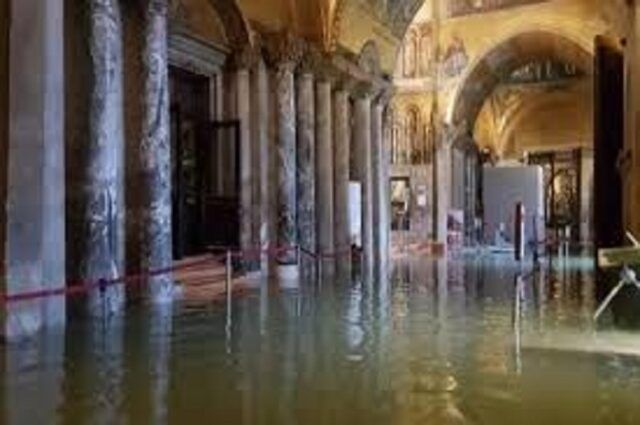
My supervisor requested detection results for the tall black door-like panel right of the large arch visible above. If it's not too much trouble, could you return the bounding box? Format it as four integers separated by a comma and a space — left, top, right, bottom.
594, 37, 624, 252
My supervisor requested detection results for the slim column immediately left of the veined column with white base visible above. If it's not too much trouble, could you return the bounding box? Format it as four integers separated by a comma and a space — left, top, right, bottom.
251, 58, 272, 272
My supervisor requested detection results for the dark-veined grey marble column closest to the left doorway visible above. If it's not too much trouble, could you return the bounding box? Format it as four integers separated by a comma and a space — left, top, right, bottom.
138, 0, 173, 304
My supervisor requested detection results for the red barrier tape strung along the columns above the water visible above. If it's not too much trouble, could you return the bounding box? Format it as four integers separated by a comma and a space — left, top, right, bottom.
0, 240, 351, 304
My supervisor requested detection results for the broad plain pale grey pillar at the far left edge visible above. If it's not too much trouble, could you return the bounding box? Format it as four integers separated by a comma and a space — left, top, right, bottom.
0, 0, 65, 340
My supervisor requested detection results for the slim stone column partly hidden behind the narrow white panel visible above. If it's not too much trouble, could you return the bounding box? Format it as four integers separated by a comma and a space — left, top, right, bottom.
353, 93, 374, 277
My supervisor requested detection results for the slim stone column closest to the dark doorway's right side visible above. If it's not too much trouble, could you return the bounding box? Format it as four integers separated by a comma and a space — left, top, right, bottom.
230, 47, 255, 270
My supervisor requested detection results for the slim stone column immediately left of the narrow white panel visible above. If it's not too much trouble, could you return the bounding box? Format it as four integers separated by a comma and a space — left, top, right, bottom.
333, 88, 351, 274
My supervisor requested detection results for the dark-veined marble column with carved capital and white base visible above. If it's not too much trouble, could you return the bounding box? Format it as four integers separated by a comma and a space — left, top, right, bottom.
268, 34, 301, 280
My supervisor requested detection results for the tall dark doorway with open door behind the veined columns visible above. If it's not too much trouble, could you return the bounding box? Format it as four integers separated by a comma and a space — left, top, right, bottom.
170, 68, 240, 259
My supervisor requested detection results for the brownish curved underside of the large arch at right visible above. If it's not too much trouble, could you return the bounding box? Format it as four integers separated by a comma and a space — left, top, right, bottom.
446, 30, 593, 128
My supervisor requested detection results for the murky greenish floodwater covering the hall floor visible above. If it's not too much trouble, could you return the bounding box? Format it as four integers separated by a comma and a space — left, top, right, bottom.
0, 253, 640, 425
